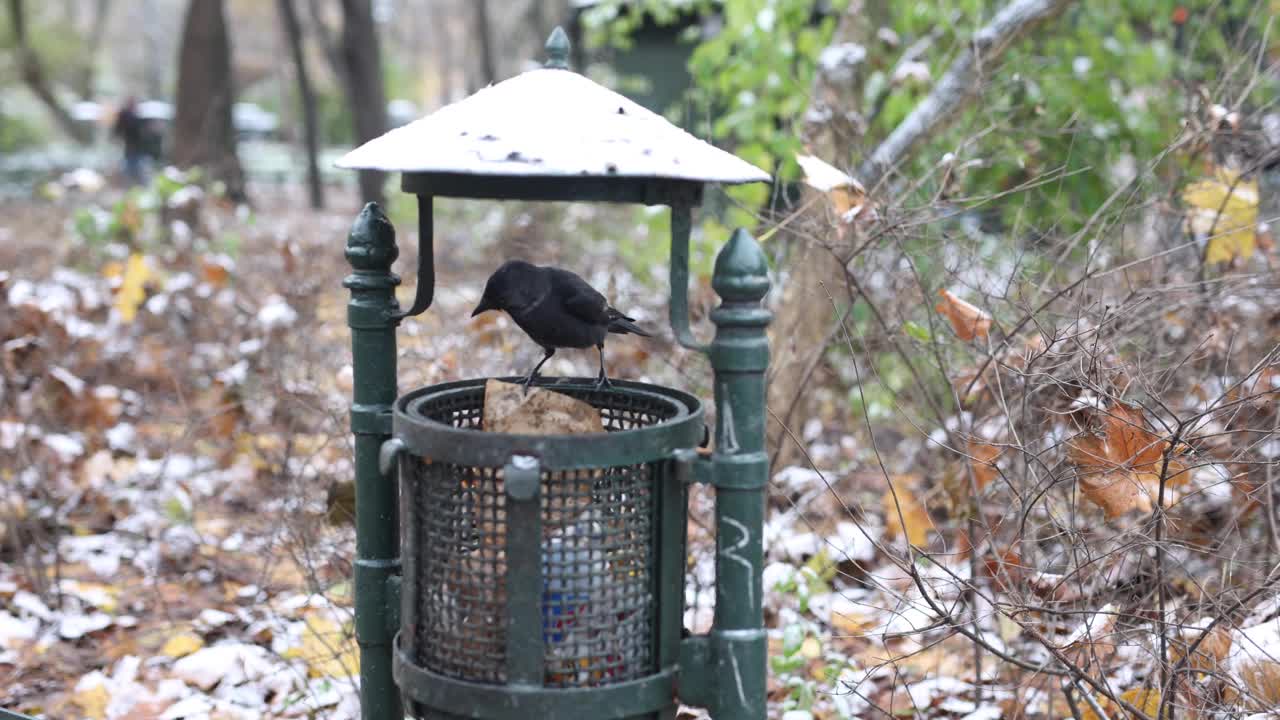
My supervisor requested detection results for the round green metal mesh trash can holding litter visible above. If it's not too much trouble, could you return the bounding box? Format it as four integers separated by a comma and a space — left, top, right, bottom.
393, 378, 705, 720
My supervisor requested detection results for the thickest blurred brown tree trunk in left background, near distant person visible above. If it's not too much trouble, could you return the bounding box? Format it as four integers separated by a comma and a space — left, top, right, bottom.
170, 0, 244, 201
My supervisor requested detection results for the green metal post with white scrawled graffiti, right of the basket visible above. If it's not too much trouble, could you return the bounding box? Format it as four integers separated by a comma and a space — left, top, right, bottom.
680, 229, 771, 720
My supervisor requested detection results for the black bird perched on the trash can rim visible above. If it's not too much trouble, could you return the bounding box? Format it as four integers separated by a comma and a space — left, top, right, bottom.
471, 260, 653, 389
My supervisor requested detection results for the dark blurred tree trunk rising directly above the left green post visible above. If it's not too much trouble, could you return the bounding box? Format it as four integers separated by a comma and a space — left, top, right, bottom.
339, 0, 387, 202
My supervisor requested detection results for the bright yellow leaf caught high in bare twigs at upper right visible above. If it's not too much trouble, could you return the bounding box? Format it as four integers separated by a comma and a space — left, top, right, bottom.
1183, 168, 1258, 264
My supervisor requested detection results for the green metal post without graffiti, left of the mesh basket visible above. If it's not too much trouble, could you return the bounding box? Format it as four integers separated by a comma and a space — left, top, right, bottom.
342, 202, 404, 720
